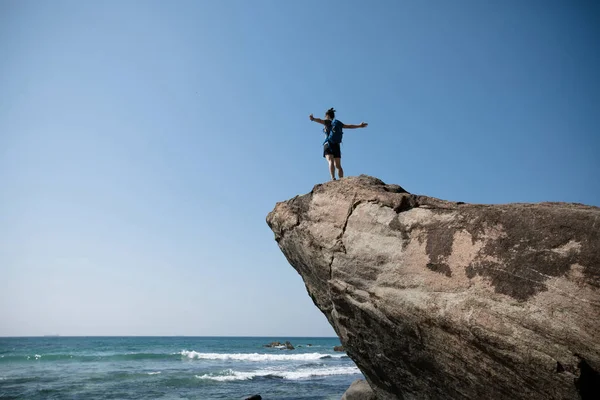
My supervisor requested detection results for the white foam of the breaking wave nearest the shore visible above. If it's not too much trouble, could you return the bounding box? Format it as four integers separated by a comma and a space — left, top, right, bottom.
196, 367, 360, 382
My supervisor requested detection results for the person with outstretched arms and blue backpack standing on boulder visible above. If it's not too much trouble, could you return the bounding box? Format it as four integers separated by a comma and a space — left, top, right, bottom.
308, 108, 368, 181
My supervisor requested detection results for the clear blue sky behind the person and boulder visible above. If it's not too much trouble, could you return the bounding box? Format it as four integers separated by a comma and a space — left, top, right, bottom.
0, 0, 600, 335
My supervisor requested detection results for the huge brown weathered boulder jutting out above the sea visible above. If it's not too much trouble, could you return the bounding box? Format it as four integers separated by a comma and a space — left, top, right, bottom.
267, 176, 600, 400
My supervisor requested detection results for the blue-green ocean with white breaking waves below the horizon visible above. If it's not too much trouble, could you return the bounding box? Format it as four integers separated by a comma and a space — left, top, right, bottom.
0, 337, 362, 400
